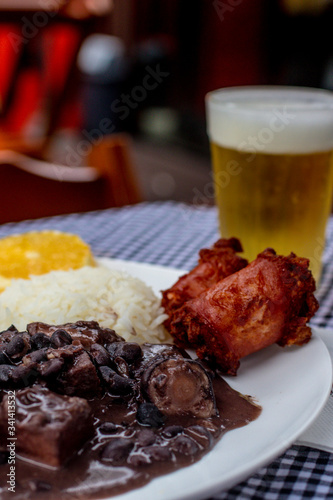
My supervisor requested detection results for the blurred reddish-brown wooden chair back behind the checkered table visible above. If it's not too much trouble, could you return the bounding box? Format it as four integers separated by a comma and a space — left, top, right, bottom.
0, 134, 141, 224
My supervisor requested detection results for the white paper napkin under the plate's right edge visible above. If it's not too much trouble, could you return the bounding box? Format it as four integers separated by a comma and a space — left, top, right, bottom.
296, 329, 333, 453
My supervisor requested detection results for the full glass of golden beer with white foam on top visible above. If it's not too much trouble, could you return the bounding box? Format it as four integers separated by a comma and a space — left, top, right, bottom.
206, 86, 333, 280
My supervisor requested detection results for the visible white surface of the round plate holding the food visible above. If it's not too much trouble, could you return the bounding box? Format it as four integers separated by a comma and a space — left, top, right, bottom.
96, 259, 333, 500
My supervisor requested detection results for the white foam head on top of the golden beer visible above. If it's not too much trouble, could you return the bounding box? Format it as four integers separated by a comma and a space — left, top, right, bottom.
206, 87, 333, 154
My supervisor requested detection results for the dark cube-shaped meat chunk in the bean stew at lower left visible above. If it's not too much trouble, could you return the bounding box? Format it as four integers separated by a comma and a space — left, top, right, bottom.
0, 386, 93, 467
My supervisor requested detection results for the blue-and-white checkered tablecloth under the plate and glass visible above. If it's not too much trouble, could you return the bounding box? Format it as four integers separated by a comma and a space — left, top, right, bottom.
0, 202, 333, 500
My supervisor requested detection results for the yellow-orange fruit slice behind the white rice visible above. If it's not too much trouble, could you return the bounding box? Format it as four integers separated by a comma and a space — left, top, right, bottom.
0, 230, 95, 291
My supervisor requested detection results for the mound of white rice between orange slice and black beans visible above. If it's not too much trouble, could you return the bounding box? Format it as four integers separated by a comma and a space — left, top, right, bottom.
0, 266, 170, 343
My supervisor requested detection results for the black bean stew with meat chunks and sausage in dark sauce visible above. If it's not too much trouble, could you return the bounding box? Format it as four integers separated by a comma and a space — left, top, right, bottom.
0, 321, 261, 500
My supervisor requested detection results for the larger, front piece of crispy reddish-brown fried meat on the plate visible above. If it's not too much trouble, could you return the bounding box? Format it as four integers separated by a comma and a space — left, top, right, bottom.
170, 249, 319, 375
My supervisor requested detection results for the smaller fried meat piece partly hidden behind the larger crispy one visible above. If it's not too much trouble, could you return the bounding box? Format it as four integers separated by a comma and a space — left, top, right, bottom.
162, 238, 248, 328
